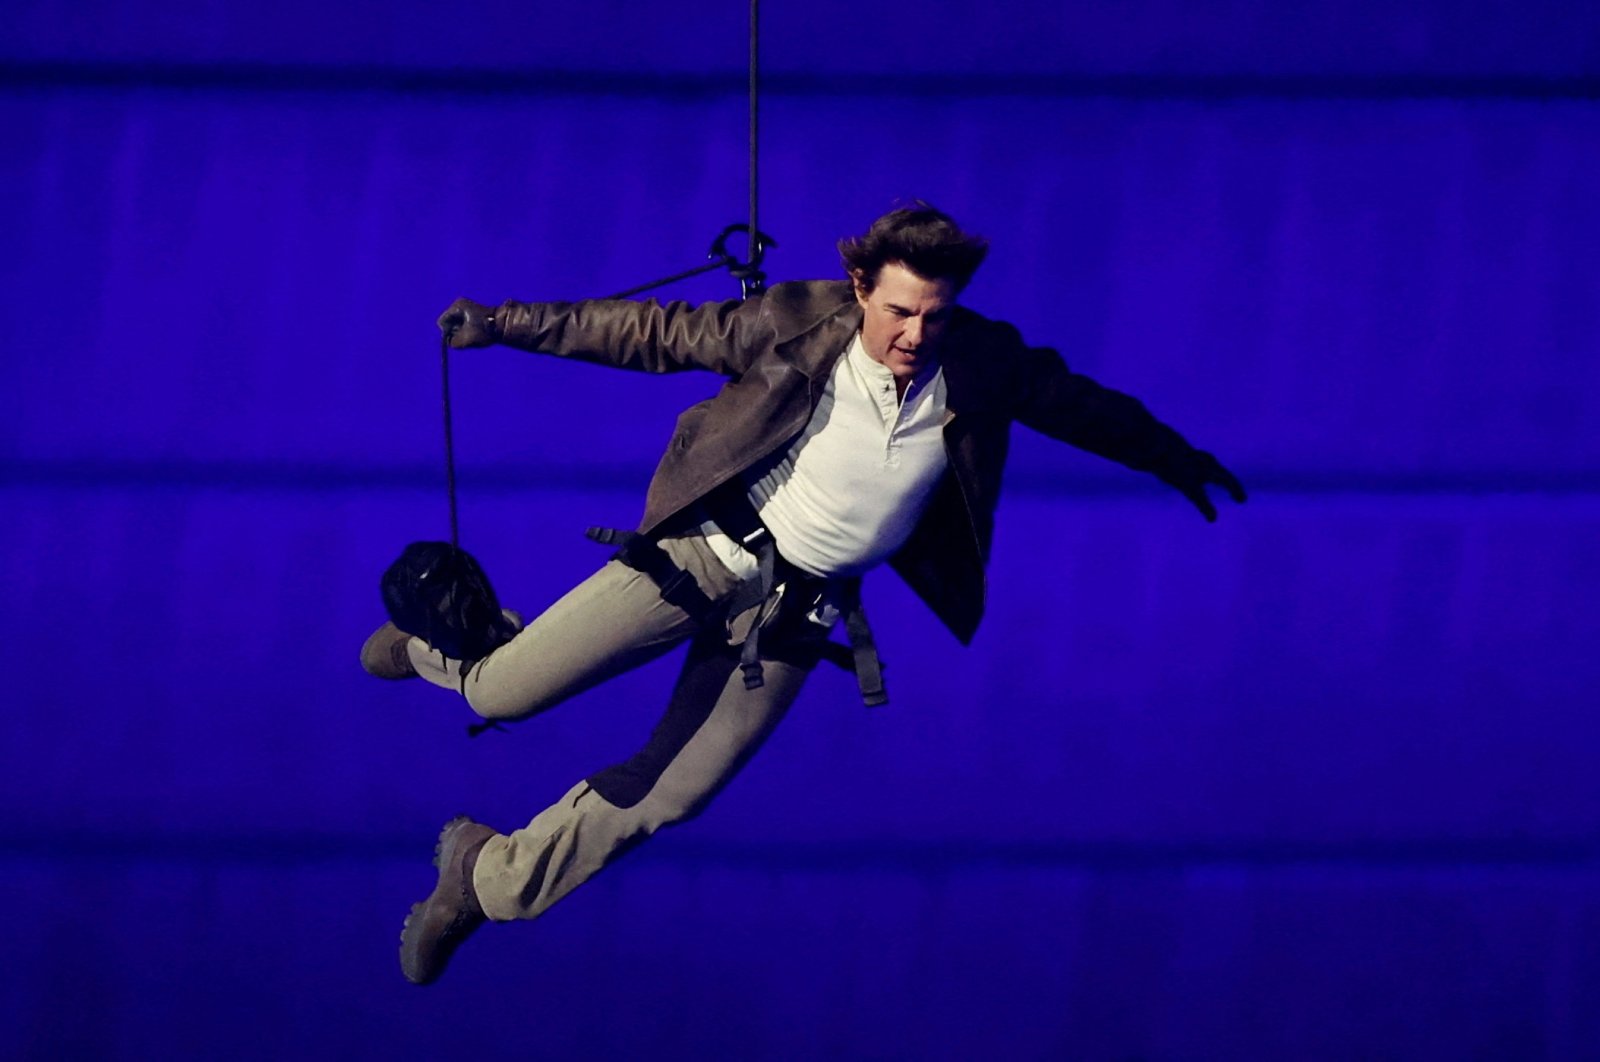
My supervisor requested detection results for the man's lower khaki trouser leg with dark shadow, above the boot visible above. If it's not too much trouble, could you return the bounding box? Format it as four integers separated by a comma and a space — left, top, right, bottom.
472, 633, 816, 921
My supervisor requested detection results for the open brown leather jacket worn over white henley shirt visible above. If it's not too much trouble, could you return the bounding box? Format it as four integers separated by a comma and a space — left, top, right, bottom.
494, 280, 1195, 643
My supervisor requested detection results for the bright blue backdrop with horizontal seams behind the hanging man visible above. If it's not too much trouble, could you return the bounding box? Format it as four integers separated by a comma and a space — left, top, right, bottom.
0, 0, 1600, 1059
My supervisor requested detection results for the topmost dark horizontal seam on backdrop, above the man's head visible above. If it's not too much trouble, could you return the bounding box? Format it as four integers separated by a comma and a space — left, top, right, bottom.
0, 61, 1600, 101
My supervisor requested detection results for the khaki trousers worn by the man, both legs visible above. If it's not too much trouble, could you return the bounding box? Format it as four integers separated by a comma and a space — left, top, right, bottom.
410, 534, 827, 921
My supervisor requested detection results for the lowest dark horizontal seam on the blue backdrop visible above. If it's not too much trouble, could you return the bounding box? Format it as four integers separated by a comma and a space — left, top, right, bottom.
0, 833, 1600, 873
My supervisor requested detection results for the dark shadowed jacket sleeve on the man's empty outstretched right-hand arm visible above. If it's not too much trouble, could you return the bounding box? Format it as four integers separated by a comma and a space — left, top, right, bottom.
1003, 326, 1198, 480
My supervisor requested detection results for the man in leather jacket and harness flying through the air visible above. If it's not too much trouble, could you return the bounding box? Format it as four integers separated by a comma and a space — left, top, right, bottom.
362, 203, 1245, 984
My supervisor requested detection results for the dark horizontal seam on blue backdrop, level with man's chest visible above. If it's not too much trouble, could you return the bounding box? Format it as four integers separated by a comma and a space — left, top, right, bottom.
0, 459, 1600, 499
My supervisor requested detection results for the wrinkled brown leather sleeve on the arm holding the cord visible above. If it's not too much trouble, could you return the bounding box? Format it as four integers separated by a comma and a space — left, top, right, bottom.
494, 297, 773, 376
